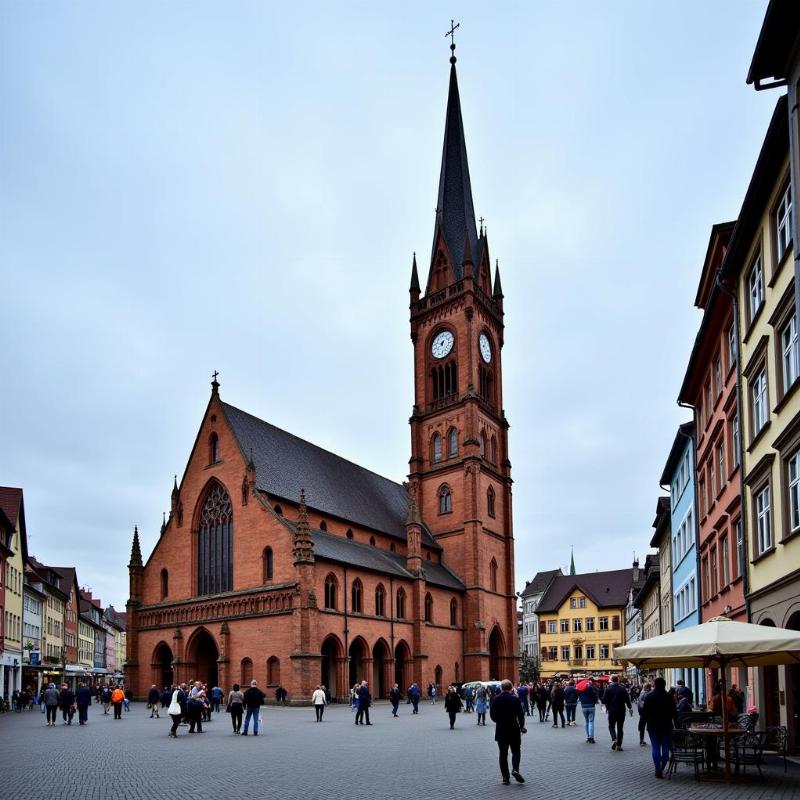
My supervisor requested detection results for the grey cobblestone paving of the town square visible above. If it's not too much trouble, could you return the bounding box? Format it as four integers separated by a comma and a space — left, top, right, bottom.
0, 703, 800, 800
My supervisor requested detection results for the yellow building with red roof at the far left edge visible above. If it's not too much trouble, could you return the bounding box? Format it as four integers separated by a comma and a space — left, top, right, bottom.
0, 486, 28, 697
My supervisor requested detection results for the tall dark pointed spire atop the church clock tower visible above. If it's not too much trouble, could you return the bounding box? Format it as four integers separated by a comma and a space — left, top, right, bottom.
431, 44, 478, 280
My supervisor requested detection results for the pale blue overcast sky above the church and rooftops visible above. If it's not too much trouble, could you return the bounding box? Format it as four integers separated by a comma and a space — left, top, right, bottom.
0, 0, 778, 607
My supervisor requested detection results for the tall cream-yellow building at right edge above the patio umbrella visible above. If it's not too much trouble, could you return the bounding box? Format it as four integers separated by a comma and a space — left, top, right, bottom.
723, 95, 800, 747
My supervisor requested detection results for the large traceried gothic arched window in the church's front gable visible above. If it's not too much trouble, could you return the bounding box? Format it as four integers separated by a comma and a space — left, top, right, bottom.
197, 483, 233, 595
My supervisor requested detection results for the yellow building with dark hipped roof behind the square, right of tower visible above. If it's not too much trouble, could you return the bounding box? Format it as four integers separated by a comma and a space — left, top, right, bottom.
537, 569, 633, 678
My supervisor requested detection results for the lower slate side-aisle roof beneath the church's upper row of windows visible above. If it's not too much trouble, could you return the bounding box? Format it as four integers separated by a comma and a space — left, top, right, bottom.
296, 520, 465, 591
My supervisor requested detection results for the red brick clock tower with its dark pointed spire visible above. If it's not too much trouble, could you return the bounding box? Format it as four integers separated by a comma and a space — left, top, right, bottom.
409, 44, 517, 680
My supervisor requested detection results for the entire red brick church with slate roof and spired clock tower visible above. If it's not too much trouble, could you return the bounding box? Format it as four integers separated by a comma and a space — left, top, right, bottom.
125, 47, 517, 700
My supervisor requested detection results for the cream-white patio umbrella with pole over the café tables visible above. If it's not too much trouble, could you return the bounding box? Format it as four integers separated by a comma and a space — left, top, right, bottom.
614, 617, 800, 777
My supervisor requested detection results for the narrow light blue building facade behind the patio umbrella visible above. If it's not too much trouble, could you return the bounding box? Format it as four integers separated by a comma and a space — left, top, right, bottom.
661, 422, 705, 704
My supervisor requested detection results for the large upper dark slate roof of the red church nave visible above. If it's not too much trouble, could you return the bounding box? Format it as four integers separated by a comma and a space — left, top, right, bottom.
222, 403, 442, 551
